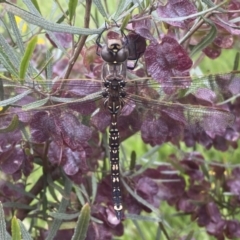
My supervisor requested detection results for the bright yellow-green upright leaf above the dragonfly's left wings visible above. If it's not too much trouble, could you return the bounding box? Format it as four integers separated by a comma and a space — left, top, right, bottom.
19, 36, 37, 83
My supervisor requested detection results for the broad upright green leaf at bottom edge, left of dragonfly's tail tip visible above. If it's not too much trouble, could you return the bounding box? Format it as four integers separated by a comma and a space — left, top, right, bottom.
72, 203, 90, 240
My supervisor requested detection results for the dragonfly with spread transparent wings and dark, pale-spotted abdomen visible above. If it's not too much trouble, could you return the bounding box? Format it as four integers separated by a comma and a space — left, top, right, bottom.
0, 26, 237, 220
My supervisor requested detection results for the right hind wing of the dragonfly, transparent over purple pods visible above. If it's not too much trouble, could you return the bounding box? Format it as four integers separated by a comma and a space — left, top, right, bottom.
124, 95, 235, 145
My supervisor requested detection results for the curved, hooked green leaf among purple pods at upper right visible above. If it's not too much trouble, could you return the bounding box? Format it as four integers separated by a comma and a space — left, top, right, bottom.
190, 18, 217, 56
